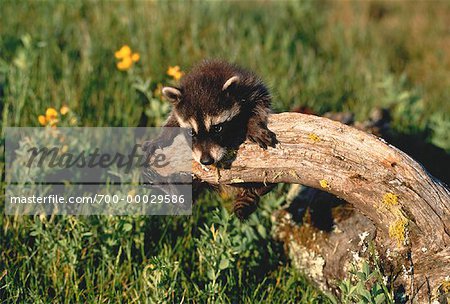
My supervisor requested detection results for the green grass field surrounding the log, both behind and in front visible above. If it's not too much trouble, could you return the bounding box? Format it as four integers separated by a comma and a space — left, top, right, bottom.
0, 1, 450, 303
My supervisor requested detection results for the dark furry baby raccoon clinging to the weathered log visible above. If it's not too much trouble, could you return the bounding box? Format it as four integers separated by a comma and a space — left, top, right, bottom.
144, 60, 276, 219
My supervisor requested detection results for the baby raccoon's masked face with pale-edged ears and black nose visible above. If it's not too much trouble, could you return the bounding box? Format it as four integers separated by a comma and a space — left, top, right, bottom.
163, 76, 247, 165
